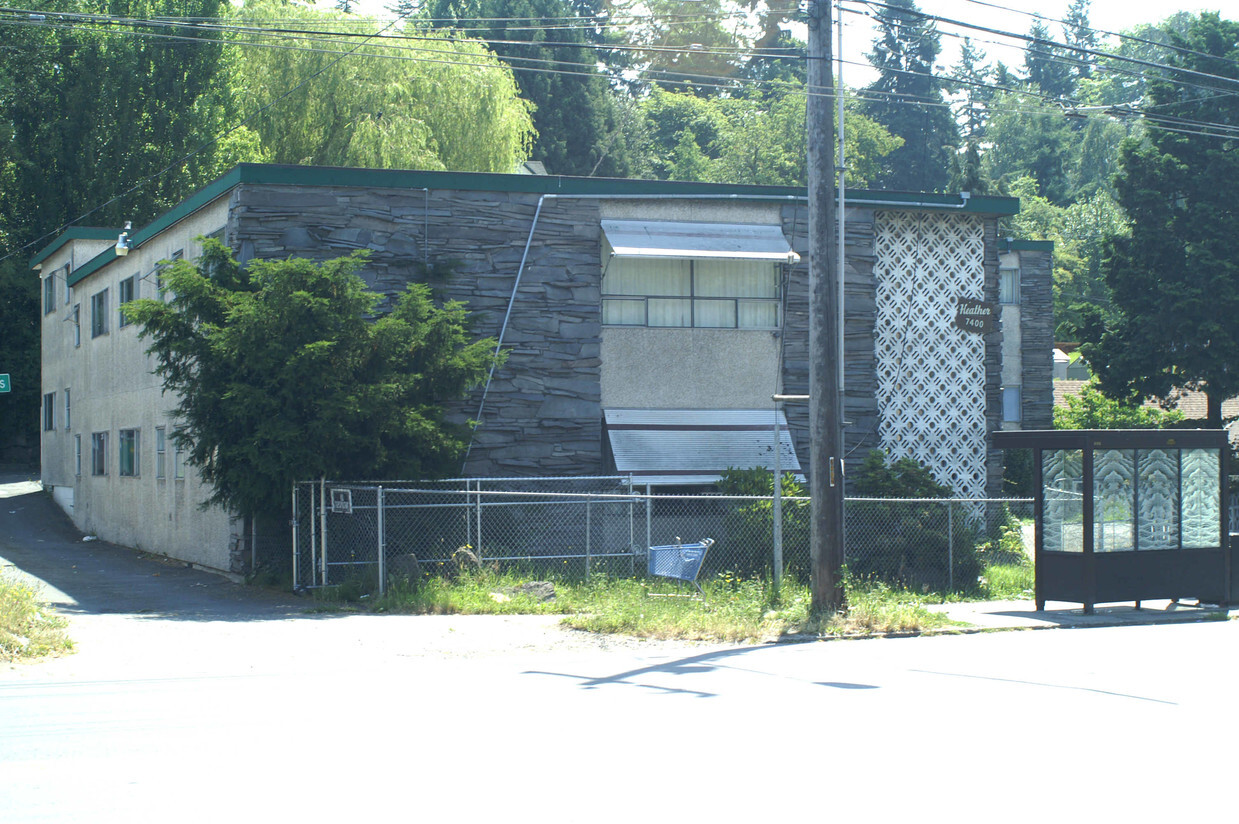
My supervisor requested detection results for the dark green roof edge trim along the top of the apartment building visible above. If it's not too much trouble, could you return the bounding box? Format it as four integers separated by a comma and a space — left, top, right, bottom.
41, 164, 1020, 286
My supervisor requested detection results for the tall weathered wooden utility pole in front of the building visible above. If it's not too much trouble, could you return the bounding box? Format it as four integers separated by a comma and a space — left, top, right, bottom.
807, 0, 846, 613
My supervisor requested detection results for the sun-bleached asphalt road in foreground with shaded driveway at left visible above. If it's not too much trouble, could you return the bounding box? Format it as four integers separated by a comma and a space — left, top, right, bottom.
0, 475, 1239, 823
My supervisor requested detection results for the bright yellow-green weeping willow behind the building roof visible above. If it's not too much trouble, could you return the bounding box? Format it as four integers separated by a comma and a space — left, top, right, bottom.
230, 0, 533, 172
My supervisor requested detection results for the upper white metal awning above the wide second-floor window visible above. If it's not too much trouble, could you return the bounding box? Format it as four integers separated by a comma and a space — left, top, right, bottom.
602, 221, 800, 263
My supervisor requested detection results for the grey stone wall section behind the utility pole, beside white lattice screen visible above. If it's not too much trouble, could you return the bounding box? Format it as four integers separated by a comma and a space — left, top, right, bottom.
783, 204, 878, 485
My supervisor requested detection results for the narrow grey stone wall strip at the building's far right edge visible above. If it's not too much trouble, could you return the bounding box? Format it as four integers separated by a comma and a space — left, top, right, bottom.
1020, 250, 1054, 429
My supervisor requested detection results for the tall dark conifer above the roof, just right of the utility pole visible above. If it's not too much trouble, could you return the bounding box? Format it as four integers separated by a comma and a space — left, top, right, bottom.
862, 0, 959, 192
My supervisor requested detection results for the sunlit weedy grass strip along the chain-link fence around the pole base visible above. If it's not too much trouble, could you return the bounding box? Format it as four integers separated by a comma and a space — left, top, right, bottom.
316, 570, 952, 642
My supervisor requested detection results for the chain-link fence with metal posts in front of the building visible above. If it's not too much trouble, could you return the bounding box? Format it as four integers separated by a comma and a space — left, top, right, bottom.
292, 477, 1033, 591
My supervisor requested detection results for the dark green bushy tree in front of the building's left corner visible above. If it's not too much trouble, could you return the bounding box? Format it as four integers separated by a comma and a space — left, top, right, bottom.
125, 240, 494, 515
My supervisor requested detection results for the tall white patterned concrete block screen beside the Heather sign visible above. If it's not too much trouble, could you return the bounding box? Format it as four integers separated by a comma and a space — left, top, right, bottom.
873, 211, 990, 498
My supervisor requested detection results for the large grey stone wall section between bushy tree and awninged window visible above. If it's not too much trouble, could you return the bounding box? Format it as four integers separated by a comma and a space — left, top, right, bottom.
227, 179, 602, 476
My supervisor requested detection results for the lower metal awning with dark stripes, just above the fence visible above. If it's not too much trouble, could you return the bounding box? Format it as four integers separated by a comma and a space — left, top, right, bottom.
602, 409, 800, 486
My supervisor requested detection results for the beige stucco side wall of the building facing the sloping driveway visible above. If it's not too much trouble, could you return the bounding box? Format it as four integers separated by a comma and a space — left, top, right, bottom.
42, 201, 232, 571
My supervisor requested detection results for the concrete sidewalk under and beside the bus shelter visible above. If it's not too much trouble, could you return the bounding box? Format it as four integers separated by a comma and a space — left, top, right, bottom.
928, 600, 1239, 629
